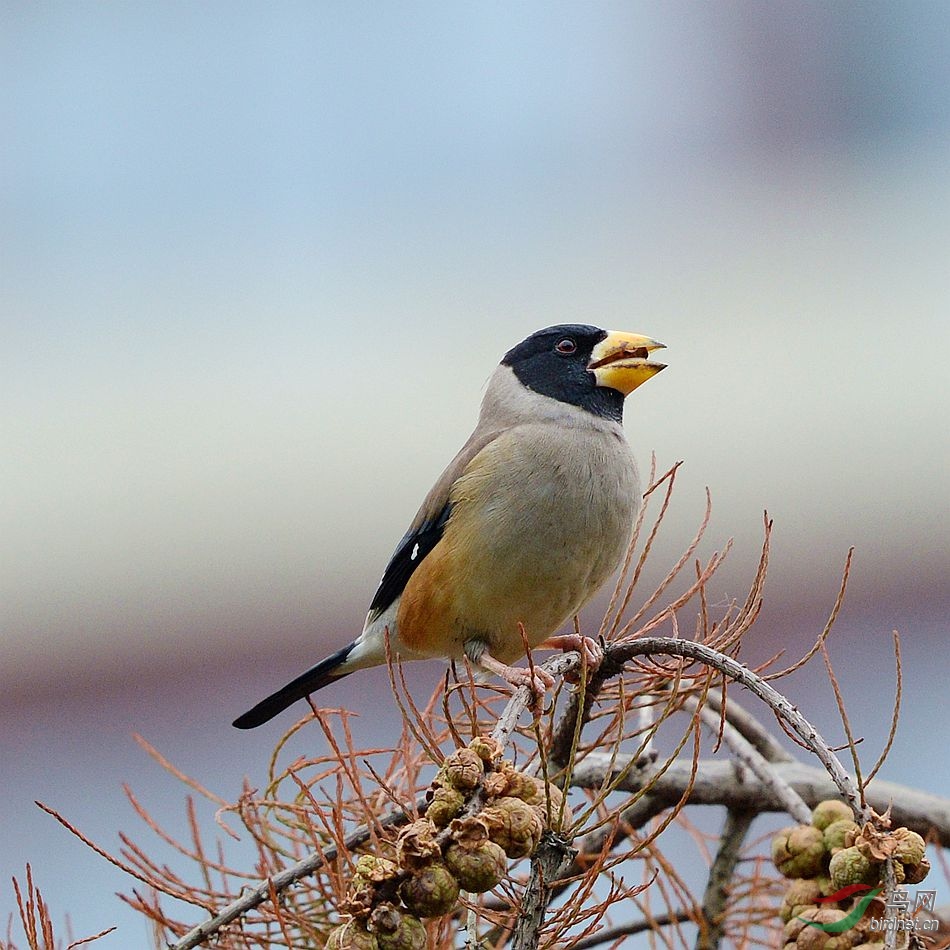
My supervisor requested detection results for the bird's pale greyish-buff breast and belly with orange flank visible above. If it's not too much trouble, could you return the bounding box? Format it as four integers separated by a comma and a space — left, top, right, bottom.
398, 420, 640, 662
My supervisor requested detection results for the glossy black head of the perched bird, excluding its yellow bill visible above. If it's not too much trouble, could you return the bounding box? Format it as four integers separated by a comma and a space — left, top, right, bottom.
501, 323, 624, 422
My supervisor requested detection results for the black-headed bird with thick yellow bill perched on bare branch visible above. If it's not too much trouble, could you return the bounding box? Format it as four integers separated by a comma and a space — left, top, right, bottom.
234, 324, 666, 729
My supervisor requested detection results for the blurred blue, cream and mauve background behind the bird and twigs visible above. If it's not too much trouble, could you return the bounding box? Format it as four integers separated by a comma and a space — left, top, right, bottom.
0, 0, 950, 947
